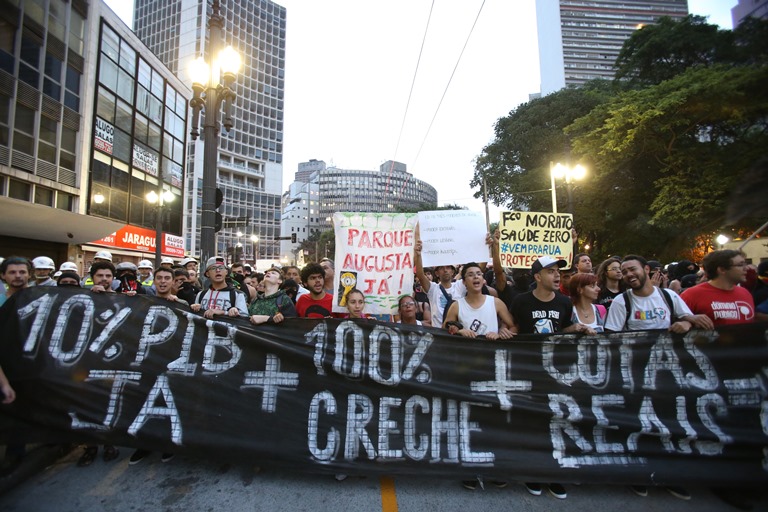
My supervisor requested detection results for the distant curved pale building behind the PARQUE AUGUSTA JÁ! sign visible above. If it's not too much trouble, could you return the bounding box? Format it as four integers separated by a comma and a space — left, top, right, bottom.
281, 160, 437, 262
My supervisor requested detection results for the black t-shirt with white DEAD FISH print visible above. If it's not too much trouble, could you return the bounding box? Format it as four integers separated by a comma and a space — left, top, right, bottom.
512, 292, 573, 334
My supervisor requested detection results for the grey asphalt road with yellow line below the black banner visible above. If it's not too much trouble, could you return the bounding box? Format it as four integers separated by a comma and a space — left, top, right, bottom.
0, 448, 768, 512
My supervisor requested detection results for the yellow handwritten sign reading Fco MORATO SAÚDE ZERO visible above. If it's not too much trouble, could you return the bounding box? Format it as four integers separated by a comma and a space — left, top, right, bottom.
499, 212, 573, 268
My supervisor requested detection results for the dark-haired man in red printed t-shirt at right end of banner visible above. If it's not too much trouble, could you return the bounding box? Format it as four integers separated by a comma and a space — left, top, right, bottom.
681, 249, 755, 327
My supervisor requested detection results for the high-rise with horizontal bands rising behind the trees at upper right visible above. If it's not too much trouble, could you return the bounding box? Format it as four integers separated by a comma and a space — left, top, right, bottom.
536, 0, 688, 96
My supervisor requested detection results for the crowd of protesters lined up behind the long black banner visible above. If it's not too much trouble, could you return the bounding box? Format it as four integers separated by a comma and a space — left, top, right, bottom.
0, 241, 768, 506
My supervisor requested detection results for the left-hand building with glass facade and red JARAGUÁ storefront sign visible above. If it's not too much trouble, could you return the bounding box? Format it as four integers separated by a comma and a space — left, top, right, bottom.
0, 0, 192, 273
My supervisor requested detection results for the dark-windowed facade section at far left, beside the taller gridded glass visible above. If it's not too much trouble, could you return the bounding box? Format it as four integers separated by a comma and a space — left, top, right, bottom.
0, 0, 88, 211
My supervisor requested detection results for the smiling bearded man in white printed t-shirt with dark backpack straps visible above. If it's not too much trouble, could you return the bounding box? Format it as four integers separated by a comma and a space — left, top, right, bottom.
605, 254, 699, 334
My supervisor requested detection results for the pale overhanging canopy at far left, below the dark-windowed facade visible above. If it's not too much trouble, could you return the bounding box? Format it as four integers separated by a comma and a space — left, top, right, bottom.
0, 196, 125, 244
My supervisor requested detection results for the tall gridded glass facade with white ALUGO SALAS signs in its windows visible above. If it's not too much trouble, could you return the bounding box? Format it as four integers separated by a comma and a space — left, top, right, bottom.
88, 21, 187, 235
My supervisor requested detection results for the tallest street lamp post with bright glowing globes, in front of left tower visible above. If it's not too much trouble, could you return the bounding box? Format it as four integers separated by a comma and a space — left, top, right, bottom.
189, 0, 240, 262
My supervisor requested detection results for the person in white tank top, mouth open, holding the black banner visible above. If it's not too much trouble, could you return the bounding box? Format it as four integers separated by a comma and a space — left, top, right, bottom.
443, 263, 514, 340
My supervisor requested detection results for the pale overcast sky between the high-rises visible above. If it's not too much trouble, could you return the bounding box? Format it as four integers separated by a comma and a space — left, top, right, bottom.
107, 0, 737, 218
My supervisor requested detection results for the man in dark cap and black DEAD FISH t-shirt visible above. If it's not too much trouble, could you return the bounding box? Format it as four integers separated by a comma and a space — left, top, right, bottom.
512, 256, 594, 334
